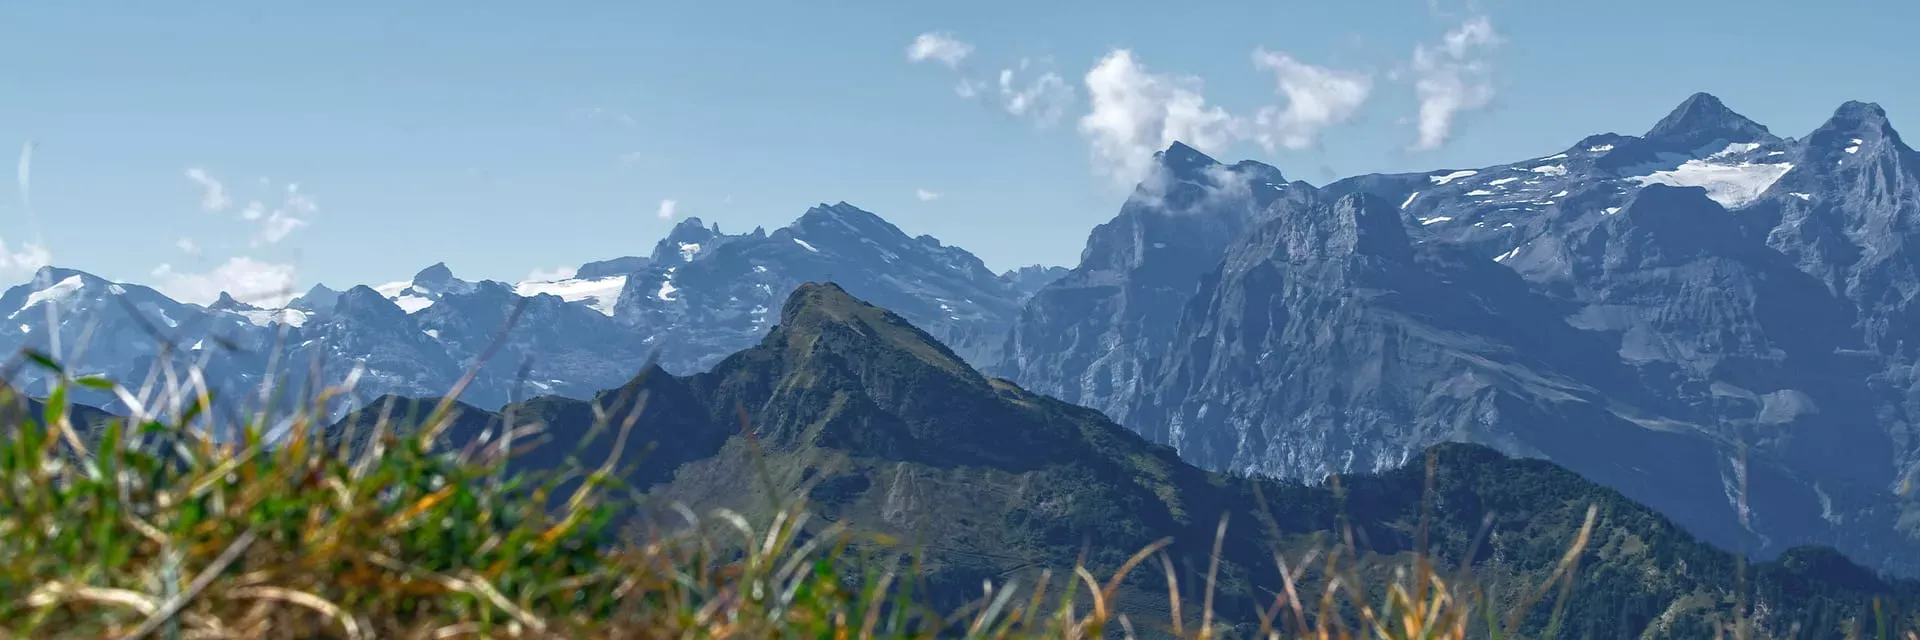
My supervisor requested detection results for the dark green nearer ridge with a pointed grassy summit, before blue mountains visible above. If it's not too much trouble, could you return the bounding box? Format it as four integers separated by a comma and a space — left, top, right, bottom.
326, 284, 1920, 638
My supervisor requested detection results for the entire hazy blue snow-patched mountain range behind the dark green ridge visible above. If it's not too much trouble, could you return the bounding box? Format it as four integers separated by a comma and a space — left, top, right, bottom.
11, 94, 1920, 575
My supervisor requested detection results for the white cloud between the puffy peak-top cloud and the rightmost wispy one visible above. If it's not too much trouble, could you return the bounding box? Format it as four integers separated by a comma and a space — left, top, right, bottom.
1254, 48, 1373, 152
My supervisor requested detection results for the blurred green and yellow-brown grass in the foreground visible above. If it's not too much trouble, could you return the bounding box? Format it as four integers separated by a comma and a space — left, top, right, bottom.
0, 353, 1873, 638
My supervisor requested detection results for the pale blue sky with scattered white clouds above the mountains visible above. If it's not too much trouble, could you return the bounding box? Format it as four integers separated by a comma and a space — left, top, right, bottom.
0, 0, 1920, 304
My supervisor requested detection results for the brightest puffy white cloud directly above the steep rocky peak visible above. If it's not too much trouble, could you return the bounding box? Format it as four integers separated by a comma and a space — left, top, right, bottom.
1079, 48, 1242, 185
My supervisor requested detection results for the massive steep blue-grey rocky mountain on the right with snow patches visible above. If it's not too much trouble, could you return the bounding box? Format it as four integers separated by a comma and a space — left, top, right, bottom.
1008, 94, 1920, 575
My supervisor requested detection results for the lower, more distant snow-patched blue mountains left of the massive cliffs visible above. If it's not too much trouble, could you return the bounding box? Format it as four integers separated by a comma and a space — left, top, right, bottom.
0, 204, 1064, 409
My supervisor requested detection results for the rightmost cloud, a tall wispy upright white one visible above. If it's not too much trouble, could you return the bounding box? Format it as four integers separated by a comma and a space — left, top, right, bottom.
1413, 15, 1501, 150
